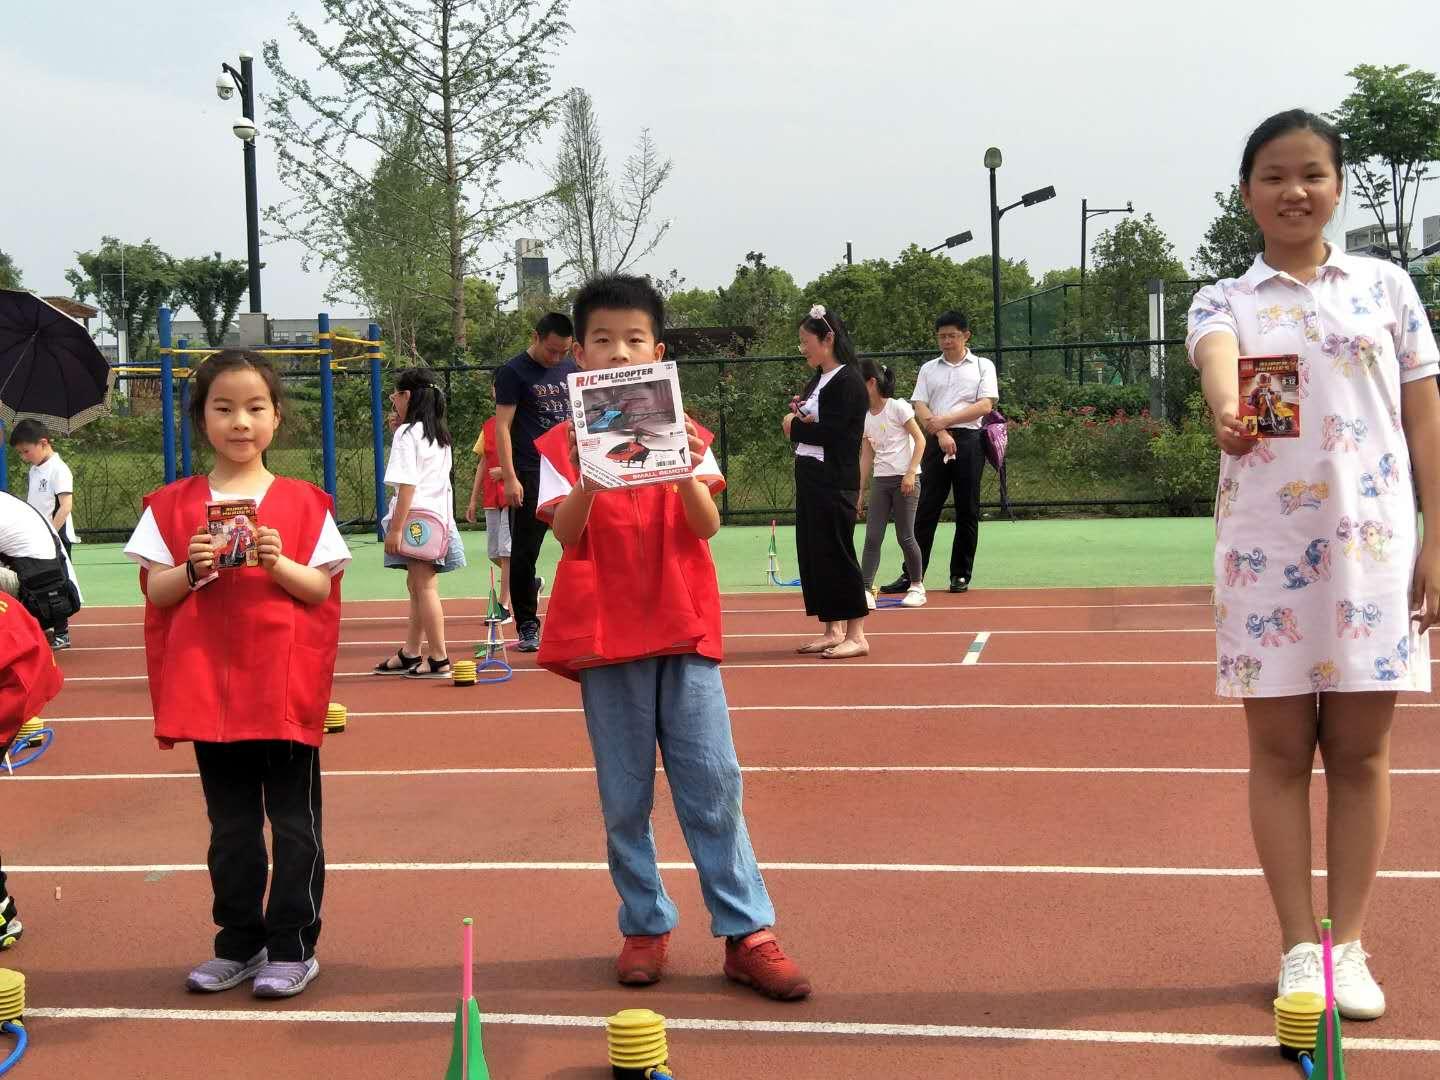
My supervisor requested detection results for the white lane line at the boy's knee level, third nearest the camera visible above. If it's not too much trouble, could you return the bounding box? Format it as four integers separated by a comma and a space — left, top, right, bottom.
14, 765, 1440, 783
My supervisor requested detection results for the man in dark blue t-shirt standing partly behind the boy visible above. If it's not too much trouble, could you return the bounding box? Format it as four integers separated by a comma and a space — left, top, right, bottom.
495, 311, 579, 652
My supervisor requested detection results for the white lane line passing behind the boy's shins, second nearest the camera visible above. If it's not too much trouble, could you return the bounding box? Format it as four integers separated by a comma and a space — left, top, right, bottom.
6, 860, 1440, 881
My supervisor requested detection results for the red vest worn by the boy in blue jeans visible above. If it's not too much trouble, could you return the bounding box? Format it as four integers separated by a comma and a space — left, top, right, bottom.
536, 422, 723, 678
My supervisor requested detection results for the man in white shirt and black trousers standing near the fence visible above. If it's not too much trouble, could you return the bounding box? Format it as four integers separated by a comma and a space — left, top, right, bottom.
880, 311, 999, 593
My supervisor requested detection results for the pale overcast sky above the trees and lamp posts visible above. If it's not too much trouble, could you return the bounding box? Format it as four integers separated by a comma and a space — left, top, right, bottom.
0, 0, 1440, 332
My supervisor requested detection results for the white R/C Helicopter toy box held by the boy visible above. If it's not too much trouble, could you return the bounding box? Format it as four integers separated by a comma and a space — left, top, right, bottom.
570, 360, 694, 488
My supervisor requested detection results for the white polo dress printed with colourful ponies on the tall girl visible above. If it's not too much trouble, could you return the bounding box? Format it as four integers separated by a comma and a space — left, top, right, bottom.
1187, 248, 1440, 697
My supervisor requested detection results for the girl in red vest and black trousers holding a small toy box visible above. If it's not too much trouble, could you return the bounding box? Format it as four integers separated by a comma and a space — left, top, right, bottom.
125, 350, 350, 998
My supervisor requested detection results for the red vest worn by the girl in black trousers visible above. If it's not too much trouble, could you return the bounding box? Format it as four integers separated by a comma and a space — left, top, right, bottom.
140, 477, 340, 749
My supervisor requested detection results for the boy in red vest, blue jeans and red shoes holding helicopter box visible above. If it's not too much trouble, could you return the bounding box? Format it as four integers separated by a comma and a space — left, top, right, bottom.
536, 275, 811, 1001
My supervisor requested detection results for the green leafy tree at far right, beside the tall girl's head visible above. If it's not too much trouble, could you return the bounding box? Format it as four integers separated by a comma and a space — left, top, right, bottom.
1331, 63, 1440, 266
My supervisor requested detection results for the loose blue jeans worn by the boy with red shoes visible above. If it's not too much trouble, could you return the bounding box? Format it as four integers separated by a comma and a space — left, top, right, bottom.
580, 654, 775, 937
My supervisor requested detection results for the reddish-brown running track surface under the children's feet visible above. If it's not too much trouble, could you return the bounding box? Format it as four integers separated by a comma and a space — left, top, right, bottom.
11, 589, 1440, 1080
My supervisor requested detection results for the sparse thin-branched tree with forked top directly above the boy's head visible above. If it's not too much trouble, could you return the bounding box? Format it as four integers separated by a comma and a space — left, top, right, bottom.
549, 88, 671, 278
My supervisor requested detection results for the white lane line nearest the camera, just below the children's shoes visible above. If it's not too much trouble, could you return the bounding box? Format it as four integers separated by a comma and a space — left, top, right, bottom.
24, 1007, 1440, 1054
